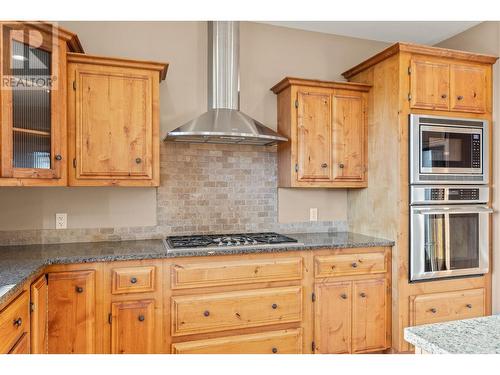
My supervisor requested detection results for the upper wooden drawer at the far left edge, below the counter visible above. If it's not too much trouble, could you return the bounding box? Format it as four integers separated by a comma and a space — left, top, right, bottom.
0, 292, 29, 353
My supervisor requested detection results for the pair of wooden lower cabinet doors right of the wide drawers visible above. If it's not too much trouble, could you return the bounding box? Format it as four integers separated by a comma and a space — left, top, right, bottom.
314, 279, 388, 354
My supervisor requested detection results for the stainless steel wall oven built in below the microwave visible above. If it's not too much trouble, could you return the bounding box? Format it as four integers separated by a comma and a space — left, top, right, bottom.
410, 185, 493, 281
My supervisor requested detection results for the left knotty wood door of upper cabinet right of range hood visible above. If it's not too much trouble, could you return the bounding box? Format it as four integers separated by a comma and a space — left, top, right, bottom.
297, 91, 332, 181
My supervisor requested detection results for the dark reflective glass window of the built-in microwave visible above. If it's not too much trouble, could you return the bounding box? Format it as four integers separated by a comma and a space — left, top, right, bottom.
421, 130, 474, 168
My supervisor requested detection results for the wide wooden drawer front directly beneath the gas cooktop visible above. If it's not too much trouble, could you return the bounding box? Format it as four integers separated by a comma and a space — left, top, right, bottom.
172, 258, 302, 289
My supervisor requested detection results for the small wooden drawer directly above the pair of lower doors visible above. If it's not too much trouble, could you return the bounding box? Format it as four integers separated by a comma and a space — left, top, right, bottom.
314, 251, 386, 277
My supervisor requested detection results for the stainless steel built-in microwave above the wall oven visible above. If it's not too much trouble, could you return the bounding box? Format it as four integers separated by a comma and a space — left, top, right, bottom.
410, 115, 489, 184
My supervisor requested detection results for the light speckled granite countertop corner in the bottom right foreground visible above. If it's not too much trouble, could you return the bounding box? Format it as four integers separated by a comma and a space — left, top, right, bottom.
404, 315, 500, 354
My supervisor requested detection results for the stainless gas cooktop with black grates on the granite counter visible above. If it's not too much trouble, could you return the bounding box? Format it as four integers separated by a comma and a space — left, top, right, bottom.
165, 232, 297, 249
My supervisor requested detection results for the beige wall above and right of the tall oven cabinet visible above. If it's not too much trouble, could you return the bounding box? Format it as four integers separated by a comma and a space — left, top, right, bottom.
438, 22, 500, 313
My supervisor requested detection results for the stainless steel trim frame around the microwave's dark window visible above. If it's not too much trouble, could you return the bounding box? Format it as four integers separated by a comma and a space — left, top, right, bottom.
409, 115, 489, 185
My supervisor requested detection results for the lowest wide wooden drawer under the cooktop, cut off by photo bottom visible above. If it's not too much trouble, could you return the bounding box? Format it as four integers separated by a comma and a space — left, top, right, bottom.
172, 328, 302, 354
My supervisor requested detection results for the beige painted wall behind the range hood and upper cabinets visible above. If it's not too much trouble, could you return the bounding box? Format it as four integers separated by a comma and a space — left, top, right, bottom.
0, 22, 386, 230
